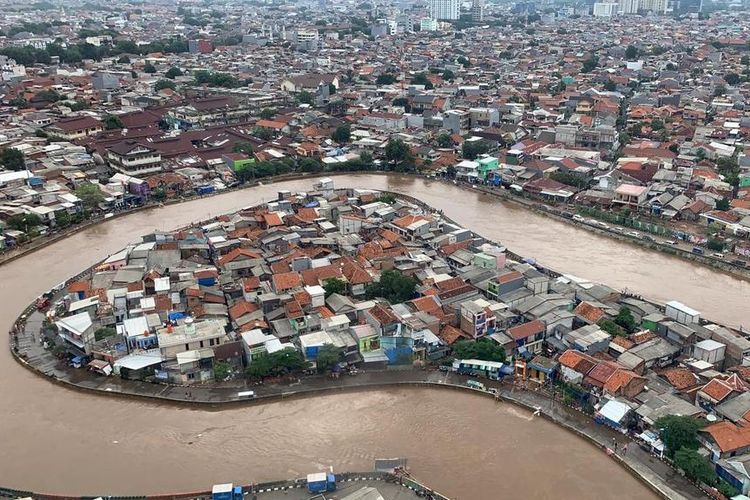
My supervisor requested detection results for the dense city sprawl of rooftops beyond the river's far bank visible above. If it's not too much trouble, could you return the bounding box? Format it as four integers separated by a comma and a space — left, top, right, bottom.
0, 6, 750, 267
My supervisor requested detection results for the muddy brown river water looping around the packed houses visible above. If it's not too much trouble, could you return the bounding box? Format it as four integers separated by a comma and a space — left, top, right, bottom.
0, 175, 748, 499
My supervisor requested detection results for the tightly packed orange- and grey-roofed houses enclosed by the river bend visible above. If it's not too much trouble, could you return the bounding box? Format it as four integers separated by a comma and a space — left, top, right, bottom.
43, 178, 750, 492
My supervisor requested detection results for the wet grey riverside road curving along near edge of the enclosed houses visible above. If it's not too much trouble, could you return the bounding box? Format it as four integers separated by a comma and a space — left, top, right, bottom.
11, 311, 705, 500
